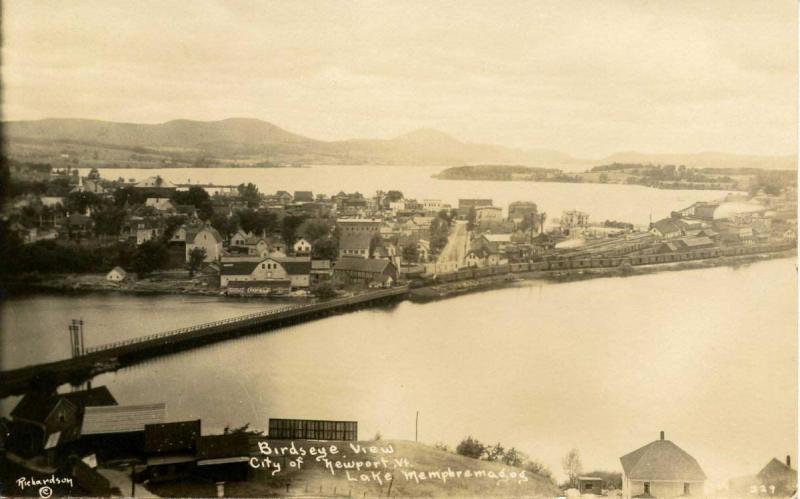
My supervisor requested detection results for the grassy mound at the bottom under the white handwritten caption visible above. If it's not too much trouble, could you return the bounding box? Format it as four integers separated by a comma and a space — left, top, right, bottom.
150, 440, 558, 497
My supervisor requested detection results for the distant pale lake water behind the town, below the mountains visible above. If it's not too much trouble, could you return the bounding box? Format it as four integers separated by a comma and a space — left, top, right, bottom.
82, 165, 727, 225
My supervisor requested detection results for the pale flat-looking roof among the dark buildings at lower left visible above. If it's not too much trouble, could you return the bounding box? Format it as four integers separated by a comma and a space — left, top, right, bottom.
81, 402, 167, 435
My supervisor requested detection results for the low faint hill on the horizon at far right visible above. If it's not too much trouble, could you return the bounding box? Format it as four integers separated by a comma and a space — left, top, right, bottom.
595, 151, 797, 170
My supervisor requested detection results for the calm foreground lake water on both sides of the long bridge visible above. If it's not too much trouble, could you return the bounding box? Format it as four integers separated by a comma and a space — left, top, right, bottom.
0, 258, 797, 483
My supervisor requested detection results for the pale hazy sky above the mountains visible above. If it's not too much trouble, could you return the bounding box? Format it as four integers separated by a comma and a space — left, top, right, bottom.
2, 0, 797, 157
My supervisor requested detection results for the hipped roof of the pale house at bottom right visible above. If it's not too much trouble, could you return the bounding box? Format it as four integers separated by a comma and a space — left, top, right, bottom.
619, 440, 706, 482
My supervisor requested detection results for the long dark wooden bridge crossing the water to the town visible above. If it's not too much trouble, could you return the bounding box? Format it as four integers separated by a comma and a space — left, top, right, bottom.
0, 286, 408, 398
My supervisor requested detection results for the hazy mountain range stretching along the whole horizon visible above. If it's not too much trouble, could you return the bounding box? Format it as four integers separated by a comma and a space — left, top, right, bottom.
3, 118, 796, 170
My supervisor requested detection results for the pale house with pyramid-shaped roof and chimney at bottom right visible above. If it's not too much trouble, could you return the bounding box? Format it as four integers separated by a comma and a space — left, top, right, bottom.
619, 431, 706, 499
